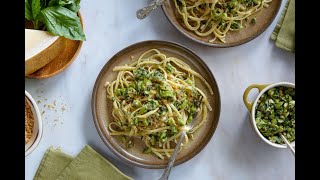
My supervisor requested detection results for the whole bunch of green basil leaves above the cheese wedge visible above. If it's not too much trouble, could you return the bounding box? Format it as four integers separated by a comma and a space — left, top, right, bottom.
25, 0, 86, 41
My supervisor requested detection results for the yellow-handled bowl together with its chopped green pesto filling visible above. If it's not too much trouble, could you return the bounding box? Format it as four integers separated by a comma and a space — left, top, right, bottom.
243, 82, 295, 148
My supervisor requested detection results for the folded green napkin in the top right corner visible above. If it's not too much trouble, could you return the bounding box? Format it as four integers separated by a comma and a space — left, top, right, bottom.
271, 0, 295, 52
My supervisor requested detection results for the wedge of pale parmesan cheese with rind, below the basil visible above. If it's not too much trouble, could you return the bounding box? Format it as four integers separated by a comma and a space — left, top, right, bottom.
25, 29, 64, 75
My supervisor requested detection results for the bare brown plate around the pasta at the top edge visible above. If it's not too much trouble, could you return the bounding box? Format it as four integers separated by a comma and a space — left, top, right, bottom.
162, 0, 282, 48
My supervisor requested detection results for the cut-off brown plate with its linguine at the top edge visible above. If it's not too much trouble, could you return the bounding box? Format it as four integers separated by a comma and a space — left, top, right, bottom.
162, 0, 282, 47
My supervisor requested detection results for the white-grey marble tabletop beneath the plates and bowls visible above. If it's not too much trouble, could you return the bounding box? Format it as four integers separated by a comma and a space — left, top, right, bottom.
25, 0, 295, 180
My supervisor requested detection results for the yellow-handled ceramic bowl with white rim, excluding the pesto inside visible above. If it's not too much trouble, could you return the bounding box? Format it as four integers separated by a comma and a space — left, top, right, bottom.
243, 82, 295, 148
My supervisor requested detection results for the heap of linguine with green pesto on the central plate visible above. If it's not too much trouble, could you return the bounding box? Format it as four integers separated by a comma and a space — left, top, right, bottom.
105, 49, 213, 159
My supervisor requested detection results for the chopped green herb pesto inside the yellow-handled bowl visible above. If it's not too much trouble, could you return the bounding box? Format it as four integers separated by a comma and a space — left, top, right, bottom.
255, 87, 295, 144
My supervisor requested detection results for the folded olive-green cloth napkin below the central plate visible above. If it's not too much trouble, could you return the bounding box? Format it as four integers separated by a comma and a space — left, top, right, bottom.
34, 145, 132, 180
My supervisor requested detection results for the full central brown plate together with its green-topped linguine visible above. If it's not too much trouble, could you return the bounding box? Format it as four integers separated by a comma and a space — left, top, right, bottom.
92, 41, 220, 168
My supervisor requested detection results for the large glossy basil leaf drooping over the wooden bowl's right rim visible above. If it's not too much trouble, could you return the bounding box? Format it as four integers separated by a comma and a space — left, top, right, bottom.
40, 6, 86, 41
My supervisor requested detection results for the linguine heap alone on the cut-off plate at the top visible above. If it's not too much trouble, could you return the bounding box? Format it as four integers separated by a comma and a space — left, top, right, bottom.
173, 0, 272, 43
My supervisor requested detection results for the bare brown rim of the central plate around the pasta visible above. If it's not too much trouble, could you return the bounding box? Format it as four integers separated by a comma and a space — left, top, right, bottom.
92, 41, 220, 168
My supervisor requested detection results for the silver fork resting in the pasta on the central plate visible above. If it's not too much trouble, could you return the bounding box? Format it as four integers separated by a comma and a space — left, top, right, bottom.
159, 96, 203, 180
